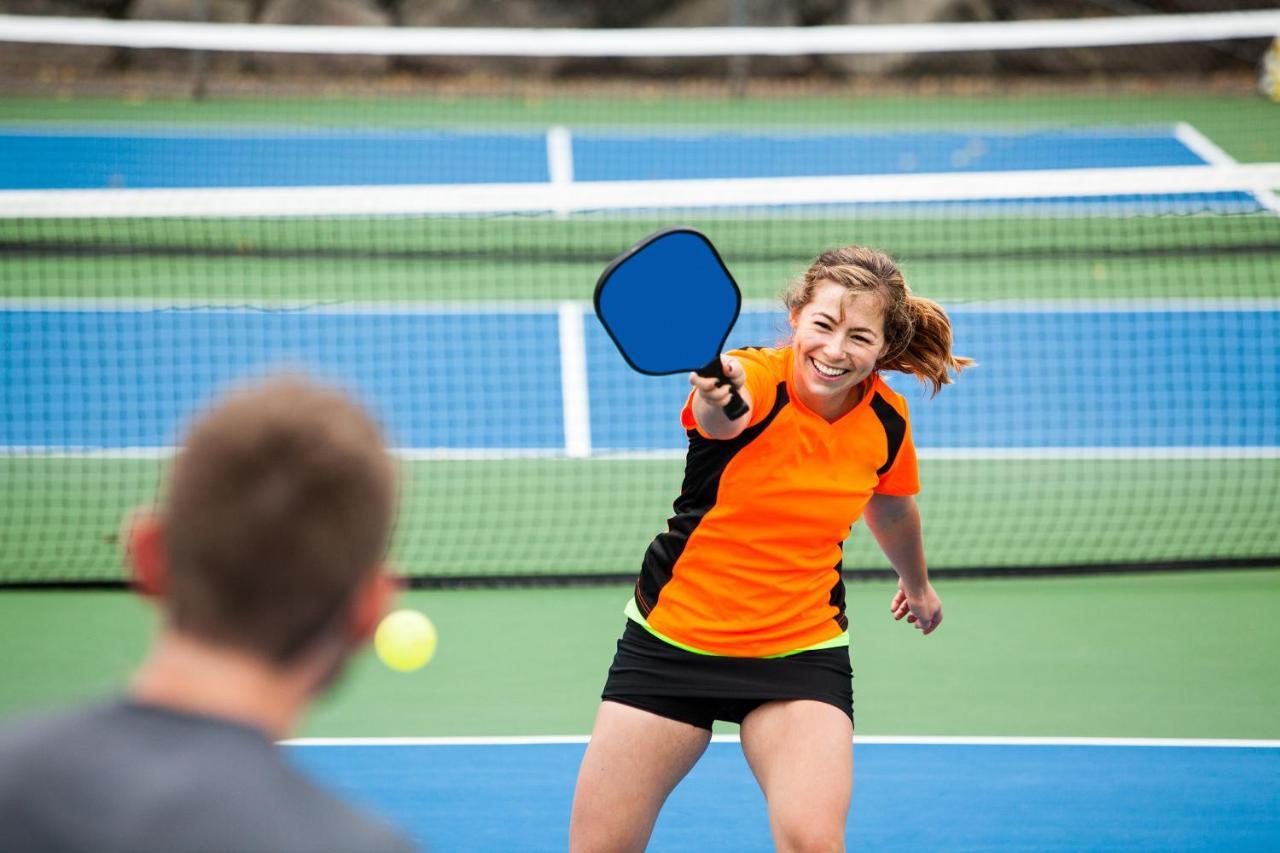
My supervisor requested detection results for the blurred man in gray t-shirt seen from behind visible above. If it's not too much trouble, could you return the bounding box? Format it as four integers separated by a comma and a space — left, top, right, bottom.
0, 379, 412, 853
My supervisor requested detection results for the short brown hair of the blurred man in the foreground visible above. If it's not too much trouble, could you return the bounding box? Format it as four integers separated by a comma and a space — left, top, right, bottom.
161, 378, 396, 663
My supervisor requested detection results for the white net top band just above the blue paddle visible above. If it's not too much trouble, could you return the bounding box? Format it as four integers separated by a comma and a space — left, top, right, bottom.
0, 163, 1280, 218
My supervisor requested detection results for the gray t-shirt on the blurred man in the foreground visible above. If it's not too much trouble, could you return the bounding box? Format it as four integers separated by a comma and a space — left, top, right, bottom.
0, 701, 413, 853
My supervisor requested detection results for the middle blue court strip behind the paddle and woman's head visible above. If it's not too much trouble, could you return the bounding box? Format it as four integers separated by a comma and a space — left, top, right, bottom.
0, 304, 1280, 453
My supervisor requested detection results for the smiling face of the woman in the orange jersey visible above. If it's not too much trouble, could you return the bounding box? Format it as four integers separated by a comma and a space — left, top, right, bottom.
790, 280, 884, 415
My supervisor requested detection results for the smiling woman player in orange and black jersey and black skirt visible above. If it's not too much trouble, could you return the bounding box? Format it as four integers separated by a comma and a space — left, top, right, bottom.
570, 246, 973, 853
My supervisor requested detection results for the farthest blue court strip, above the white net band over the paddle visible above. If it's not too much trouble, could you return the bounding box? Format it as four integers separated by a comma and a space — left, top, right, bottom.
0, 127, 1223, 190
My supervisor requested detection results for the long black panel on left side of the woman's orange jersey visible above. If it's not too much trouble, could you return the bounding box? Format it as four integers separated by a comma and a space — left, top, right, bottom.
636, 382, 790, 616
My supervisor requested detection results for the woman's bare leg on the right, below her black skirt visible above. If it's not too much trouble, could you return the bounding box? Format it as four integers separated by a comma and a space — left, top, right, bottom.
742, 699, 854, 853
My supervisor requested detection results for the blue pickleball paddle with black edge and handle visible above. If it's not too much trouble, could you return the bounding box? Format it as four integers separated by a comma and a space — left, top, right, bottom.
595, 228, 746, 420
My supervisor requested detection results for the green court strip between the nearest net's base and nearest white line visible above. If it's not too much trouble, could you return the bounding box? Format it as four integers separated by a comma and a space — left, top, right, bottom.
0, 570, 1280, 739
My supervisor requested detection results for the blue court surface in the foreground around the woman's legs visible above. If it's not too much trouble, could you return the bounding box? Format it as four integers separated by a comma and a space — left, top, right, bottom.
291, 742, 1280, 853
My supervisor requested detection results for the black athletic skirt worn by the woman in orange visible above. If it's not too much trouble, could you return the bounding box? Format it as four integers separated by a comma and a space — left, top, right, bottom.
600, 619, 854, 729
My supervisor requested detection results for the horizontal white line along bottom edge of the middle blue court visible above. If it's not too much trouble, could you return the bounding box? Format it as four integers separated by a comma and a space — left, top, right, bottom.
0, 445, 1280, 462
